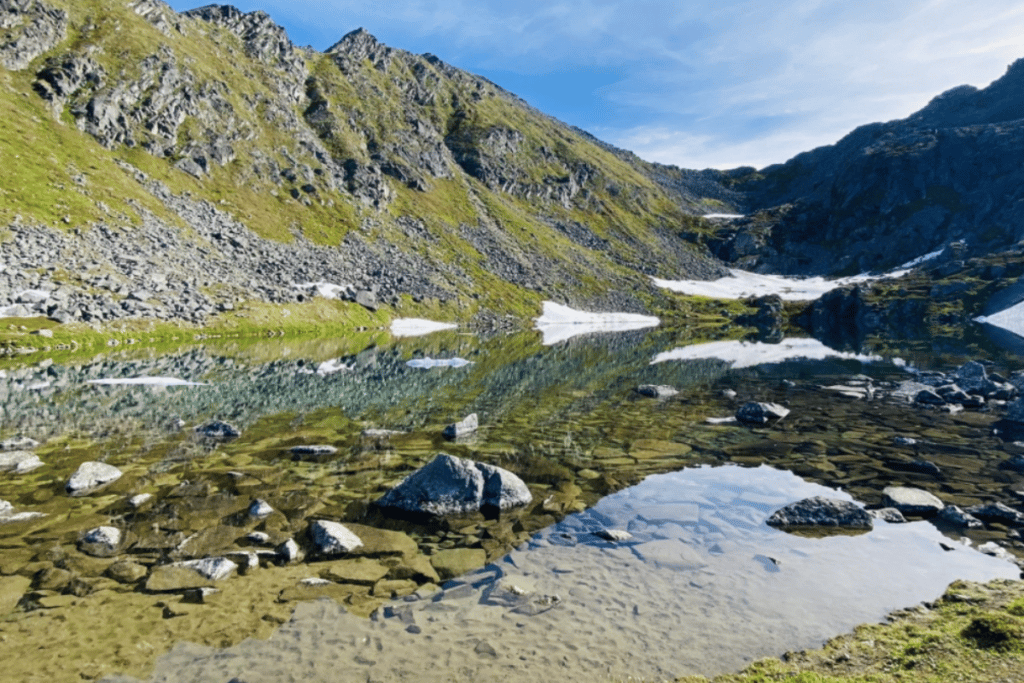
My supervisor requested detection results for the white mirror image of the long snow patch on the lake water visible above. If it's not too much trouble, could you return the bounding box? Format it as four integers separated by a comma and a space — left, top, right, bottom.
650, 338, 883, 368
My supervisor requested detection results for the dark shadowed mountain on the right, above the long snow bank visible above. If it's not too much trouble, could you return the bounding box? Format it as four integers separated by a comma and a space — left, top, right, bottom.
709, 60, 1024, 275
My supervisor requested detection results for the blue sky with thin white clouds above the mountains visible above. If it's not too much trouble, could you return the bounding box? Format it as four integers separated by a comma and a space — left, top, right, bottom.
163, 0, 1024, 168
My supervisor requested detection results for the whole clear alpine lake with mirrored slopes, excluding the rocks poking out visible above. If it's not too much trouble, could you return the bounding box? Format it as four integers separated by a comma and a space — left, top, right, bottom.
0, 321, 1024, 683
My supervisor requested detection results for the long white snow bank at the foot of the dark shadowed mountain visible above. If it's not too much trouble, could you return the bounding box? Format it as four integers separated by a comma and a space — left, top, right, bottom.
651, 247, 945, 301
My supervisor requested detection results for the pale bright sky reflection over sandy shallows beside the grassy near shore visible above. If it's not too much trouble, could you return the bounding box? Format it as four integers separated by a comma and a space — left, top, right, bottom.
130, 466, 1019, 683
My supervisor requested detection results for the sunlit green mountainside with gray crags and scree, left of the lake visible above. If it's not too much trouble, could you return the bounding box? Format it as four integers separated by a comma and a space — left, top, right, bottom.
0, 0, 731, 323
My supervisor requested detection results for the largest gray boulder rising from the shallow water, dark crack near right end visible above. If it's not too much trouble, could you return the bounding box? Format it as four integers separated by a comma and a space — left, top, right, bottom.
377, 453, 534, 516
